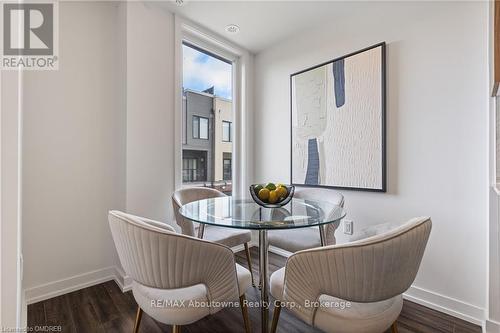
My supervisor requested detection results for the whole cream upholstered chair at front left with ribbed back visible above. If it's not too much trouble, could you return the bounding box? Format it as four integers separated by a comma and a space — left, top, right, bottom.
108, 211, 251, 333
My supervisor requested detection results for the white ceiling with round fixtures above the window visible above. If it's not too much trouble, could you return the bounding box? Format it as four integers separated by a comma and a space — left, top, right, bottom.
163, 0, 357, 53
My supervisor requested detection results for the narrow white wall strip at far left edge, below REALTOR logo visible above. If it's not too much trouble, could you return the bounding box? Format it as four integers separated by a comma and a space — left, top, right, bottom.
0, 71, 23, 328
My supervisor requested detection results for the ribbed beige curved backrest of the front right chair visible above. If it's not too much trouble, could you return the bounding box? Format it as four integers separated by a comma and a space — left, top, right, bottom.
283, 217, 432, 324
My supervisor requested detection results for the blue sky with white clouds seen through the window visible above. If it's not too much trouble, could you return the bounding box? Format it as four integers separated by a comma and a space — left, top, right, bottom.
182, 45, 232, 99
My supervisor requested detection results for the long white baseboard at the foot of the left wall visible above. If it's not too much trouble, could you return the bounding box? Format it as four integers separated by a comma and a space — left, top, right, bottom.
25, 266, 118, 304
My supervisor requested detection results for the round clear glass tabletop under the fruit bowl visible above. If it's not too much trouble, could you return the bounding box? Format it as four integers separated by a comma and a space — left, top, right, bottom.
179, 196, 346, 229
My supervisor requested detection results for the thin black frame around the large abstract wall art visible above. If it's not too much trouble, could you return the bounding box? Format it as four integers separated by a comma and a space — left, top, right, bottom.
290, 42, 387, 193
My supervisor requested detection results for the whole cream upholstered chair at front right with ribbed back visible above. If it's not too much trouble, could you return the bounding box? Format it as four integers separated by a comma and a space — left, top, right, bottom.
270, 217, 432, 333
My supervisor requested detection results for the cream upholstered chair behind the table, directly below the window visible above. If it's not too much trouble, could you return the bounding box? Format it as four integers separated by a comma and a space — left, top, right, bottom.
172, 187, 255, 286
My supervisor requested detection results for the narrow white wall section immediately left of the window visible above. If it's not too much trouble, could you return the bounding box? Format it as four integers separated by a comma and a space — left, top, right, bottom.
127, 2, 174, 223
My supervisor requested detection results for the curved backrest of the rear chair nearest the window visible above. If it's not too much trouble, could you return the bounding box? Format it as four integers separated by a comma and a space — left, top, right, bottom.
172, 187, 226, 236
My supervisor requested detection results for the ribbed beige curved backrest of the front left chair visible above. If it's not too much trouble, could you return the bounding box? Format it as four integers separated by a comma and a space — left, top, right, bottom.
108, 211, 239, 313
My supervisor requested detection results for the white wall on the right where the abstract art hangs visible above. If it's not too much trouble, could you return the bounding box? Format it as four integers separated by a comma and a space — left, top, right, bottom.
254, 2, 488, 321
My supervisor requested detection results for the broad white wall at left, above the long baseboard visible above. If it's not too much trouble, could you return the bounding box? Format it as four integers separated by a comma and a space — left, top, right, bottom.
23, 2, 126, 296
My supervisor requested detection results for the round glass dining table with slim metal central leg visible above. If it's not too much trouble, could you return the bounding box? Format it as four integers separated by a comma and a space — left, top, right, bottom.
179, 196, 346, 333
